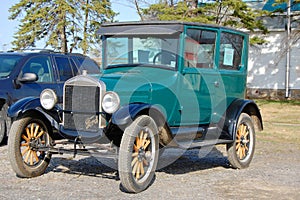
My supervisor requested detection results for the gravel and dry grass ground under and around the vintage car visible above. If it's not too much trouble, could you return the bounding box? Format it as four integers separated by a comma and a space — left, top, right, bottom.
0, 101, 300, 200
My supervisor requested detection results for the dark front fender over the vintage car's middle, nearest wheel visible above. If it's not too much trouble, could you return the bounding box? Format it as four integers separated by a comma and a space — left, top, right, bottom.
111, 103, 166, 127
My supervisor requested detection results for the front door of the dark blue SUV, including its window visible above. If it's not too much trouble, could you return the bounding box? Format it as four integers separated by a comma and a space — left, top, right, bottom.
13, 55, 59, 101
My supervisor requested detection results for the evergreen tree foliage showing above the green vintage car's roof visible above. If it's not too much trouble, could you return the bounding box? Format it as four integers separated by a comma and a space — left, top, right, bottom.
143, 0, 267, 43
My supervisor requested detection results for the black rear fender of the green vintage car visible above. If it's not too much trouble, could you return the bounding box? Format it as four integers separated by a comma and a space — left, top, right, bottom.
219, 99, 263, 141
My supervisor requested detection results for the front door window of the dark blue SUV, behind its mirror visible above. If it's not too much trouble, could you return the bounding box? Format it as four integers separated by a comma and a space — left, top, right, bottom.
22, 56, 54, 83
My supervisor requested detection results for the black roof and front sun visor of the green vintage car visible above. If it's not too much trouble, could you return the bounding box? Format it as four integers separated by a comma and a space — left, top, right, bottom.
97, 21, 246, 35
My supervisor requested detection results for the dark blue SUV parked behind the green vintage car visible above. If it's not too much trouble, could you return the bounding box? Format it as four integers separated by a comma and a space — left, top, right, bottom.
0, 50, 100, 143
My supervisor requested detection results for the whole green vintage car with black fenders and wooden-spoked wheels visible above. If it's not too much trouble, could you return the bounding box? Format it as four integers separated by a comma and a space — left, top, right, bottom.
8, 22, 263, 193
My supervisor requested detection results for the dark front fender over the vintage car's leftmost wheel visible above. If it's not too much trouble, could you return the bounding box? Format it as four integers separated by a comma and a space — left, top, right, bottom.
7, 97, 60, 130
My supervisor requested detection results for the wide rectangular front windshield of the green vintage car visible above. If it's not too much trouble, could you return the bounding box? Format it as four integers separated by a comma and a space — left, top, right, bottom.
104, 35, 178, 68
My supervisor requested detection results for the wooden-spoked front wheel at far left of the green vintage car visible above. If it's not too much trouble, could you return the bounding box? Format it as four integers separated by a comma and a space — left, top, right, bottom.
8, 117, 51, 178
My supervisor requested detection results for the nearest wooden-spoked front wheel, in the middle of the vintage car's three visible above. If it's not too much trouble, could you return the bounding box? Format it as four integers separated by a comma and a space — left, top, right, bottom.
118, 115, 159, 193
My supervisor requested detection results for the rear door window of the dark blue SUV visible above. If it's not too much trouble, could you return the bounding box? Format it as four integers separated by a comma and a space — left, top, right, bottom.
55, 57, 73, 81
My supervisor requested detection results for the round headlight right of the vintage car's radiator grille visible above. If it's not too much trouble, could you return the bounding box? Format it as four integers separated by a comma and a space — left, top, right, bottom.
102, 92, 120, 114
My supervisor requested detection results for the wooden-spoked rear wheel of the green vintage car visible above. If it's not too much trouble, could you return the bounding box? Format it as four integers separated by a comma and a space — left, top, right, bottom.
227, 113, 255, 169
